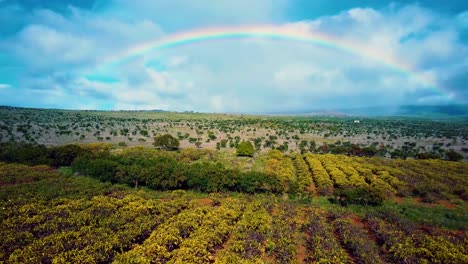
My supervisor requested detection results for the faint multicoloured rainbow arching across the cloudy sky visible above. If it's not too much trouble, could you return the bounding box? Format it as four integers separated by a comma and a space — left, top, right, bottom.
101, 25, 447, 94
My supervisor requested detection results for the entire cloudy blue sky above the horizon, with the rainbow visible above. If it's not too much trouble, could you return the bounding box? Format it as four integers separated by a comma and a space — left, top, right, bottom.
0, 0, 468, 113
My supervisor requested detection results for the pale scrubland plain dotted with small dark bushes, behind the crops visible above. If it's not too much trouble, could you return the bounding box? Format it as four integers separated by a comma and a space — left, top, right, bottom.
0, 107, 468, 158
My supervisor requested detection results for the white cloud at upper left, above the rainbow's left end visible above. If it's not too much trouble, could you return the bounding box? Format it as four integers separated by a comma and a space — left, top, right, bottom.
0, 7, 165, 71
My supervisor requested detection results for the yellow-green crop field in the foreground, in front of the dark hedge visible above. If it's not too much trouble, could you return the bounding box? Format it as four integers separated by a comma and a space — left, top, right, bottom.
0, 156, 468, 263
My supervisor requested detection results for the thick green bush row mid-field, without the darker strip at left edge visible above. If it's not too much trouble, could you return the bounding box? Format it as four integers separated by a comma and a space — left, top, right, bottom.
72, 155, 286, 193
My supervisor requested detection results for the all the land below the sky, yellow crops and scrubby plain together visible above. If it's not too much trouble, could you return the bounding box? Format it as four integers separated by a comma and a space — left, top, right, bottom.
0, 108, 468, 263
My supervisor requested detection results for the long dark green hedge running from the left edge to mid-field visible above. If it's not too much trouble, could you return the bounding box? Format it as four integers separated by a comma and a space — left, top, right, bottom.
0, 143, 297, 193
